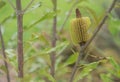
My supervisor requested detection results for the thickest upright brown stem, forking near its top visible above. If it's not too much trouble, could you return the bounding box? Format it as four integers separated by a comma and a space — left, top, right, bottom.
16, 0, 24, 78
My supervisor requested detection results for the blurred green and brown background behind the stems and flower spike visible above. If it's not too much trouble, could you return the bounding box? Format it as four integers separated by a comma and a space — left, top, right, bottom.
0, 0, 120, 82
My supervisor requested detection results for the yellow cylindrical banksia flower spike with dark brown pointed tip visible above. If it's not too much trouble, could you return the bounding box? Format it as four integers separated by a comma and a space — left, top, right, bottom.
70, 9, 91, 45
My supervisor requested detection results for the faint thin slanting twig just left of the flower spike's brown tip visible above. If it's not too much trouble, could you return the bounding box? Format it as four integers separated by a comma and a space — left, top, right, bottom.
59, 0, 79, 33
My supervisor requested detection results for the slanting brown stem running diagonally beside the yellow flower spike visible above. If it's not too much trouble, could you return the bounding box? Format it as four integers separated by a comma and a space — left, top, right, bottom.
69, 0, 117, 82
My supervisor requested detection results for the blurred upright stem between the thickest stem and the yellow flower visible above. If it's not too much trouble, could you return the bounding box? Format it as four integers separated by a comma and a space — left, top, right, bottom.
50, 0, 57, 78
